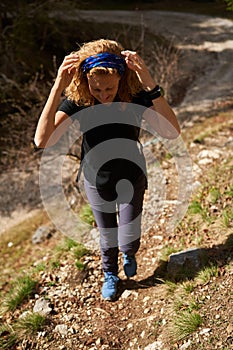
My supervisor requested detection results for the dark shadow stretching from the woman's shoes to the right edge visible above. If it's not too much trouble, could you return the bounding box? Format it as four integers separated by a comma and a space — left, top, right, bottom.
117, 234, 233, 299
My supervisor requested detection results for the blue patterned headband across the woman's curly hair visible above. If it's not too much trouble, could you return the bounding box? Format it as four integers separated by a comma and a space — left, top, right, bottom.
82, 52, 126, 76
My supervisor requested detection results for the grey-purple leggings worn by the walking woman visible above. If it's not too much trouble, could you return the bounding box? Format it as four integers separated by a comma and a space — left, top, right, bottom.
84, 175, 146, 274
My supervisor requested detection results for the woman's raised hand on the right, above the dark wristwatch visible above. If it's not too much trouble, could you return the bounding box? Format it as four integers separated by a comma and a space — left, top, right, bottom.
121, 50, 156, 90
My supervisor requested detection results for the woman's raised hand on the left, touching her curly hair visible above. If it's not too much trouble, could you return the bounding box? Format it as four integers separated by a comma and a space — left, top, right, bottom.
55, 53, 79, 91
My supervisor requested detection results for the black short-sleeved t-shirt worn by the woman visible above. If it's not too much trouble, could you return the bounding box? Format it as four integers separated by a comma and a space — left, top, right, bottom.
58, 92, 153, 188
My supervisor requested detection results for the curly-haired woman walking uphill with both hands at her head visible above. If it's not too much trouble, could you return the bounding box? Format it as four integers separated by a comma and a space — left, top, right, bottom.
34, 39, 180, 300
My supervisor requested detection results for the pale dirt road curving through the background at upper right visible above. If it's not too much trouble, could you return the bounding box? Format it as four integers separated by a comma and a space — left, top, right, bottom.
69, 10, 233, 118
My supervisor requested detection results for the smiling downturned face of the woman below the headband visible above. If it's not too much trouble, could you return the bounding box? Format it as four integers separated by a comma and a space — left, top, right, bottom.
87, 73, 120, 103
